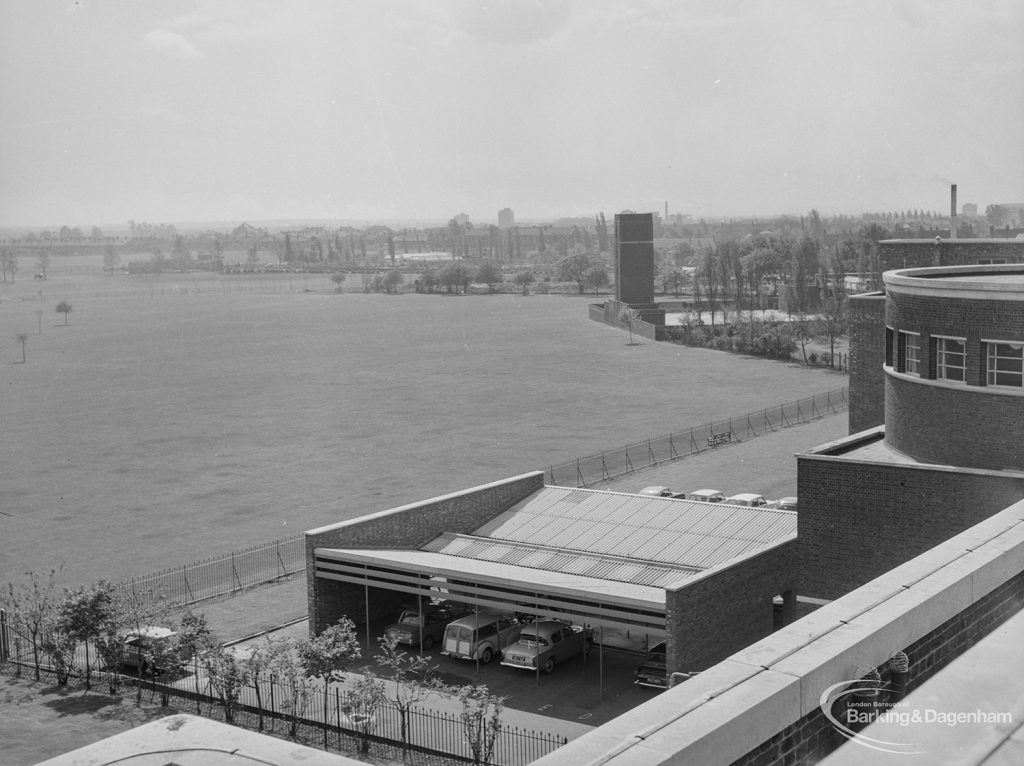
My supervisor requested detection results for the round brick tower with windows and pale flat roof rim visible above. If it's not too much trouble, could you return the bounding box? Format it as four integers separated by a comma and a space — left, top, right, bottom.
884, 264, 1024, 470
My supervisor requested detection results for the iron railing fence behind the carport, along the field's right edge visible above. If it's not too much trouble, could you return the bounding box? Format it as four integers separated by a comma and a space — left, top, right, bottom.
546, 387, 850, 486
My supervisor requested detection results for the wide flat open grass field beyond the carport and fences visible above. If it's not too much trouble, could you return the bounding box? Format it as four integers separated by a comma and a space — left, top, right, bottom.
0, 259, 846, 584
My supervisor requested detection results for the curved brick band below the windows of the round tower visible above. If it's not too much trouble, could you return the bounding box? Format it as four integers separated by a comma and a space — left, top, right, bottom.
884, 368, 1024, 471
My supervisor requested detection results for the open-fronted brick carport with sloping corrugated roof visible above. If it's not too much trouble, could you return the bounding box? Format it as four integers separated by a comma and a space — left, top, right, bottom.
306, 479, 797, 684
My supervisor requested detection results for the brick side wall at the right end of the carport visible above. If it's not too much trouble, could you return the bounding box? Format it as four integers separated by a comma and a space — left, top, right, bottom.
666, 539, 797, 673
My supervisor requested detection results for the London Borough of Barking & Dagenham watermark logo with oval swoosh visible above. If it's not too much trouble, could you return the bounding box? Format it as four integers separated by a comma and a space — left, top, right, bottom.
818, 678, 1013, 755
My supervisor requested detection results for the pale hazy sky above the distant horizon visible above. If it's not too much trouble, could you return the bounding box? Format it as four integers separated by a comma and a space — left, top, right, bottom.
0, 0, 1024, 226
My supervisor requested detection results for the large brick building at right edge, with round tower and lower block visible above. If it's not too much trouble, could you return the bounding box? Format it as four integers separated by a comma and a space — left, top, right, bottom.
797, 264, 1024, 600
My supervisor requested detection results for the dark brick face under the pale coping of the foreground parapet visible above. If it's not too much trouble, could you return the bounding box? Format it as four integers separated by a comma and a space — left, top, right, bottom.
732, 572, 1024, 766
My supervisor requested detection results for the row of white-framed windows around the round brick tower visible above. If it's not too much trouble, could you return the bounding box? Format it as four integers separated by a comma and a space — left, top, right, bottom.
886, 330, 1024, 388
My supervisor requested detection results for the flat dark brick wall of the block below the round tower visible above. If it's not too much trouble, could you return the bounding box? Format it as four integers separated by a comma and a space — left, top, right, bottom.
797, 455, 1024, 599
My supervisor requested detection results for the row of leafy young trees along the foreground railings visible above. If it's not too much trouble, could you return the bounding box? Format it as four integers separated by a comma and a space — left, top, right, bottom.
0, 569, 505, 764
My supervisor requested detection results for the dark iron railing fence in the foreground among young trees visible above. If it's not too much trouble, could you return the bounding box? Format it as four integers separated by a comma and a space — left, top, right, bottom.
0, 611, 568, 766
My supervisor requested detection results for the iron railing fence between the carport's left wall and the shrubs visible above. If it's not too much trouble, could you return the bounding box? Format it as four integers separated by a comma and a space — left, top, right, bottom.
115, 535, 306, 608
